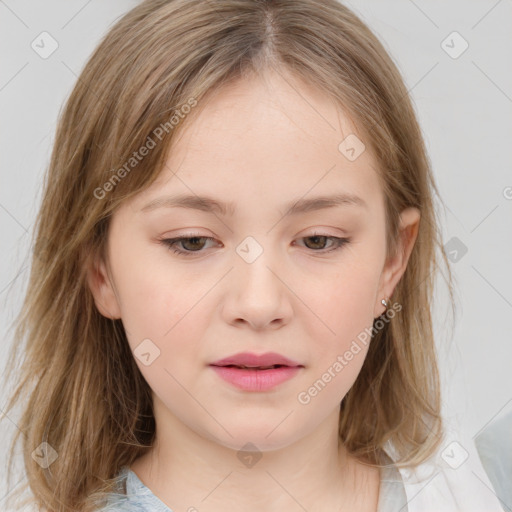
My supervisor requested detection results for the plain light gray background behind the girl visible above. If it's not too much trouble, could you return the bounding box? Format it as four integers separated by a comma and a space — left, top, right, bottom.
0, 0, 512, 505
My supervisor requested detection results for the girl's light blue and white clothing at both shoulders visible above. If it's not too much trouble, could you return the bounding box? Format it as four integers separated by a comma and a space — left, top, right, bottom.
101, 416, 507, 512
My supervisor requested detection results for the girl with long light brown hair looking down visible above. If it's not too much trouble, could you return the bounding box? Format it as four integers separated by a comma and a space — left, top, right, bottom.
0, 0, 501, 512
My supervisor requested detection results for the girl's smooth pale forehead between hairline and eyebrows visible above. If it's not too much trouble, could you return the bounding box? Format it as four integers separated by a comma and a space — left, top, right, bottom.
130, 73, 381, 214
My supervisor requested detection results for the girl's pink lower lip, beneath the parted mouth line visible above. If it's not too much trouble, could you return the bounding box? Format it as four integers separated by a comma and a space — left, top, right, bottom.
211, 365, 302, 391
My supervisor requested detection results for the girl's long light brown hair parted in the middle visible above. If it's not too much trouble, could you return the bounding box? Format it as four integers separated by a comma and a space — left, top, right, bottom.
0, 0, 453, 512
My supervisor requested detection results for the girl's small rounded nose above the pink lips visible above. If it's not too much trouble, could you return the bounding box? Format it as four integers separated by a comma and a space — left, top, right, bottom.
223, 245, 293, 331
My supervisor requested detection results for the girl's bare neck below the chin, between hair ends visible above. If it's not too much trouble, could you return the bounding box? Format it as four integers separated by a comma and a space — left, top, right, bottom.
131, 406, 380, 512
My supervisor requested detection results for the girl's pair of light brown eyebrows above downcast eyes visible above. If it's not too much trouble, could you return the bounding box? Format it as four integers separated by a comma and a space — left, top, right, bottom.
140, 193, 368, 216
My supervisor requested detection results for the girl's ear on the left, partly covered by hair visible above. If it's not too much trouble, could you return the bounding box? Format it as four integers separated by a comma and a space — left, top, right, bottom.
87, 248, 121, 319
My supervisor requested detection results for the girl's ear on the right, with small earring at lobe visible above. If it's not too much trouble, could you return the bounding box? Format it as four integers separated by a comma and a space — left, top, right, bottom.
374, 207, 420, 318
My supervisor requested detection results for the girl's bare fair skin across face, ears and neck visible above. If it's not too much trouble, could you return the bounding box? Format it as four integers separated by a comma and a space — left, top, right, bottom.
89, 69, 419, 512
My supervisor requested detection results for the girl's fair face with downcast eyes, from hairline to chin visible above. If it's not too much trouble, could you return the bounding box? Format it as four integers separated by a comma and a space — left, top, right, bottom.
90, 68, 414, 451
